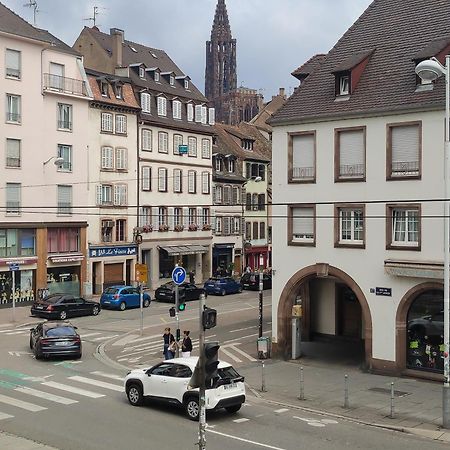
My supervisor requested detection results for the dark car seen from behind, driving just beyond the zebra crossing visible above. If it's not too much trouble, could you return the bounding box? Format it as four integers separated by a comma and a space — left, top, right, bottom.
30, 322, 81, 359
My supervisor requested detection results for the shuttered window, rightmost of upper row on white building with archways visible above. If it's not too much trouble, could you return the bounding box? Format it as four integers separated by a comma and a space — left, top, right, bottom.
386, 122, 422, 180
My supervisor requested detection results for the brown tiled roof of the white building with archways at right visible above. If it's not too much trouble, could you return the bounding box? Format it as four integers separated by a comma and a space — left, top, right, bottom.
270, 0, 450, 125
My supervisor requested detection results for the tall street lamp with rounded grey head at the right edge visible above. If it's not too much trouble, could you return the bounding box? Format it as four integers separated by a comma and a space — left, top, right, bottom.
416, 55, 450, 428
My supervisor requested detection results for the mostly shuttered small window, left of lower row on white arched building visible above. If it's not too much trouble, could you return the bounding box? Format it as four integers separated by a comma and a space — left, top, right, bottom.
288, 205, 315, 245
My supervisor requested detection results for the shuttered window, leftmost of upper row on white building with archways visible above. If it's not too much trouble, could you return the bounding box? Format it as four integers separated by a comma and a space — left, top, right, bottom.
288, 132, 316, 183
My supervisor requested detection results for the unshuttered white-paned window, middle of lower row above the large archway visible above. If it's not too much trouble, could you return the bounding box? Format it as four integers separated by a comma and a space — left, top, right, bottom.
335, 205, 365, 247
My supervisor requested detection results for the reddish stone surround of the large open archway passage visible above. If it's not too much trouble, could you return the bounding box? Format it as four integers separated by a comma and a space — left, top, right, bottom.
276, 263, 372, 369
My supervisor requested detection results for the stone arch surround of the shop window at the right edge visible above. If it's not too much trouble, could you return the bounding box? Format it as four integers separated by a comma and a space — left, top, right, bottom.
395, 281, 444, 379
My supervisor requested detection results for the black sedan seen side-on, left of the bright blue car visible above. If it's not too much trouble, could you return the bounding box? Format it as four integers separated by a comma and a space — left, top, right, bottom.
31, 294, 100, 320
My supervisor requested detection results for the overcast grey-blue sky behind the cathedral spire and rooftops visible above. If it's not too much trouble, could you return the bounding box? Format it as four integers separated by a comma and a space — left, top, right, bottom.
4, 0, 371, 100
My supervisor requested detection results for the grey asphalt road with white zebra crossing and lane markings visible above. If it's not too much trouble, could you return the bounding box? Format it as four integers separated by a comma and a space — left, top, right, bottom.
0, 293, 447, 450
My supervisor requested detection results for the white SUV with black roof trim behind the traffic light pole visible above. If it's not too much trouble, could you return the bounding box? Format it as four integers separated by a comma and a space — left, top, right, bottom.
124, 357, 245, 420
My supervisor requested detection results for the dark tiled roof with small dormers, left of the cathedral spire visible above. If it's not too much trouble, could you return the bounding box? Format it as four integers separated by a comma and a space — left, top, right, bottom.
83, 27, 208, 103
